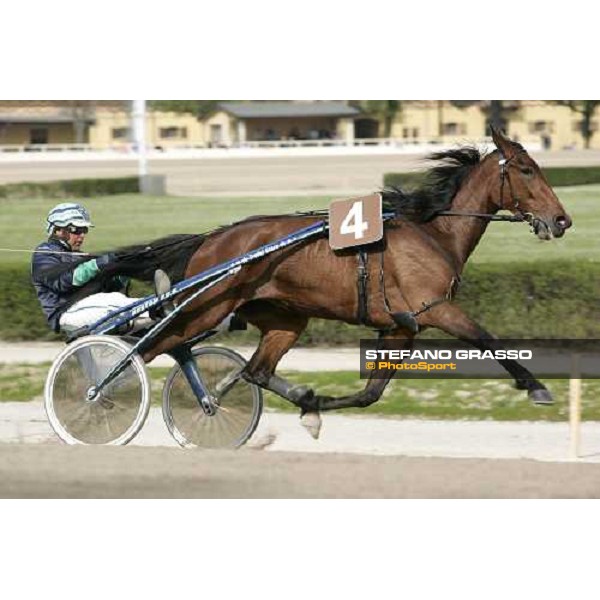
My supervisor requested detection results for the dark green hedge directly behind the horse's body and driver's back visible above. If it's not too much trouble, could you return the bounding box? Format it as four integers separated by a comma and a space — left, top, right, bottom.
0, 261, 600, 346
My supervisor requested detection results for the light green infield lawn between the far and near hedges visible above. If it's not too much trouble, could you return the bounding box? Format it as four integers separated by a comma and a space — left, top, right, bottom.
0, 185, 600, 264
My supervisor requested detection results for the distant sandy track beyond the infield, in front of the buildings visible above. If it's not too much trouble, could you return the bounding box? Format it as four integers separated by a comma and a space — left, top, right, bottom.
0, 150, 600, 196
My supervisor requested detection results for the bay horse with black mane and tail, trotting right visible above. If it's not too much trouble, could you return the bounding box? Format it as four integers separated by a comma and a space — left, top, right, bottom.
71, 129, 571, 437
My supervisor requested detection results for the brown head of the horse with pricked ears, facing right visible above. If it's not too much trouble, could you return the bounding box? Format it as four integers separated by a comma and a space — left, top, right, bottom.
491, 127, 572, 240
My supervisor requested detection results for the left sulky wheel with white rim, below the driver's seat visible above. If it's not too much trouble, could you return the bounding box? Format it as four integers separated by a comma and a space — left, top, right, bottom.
44, 335, 150, 445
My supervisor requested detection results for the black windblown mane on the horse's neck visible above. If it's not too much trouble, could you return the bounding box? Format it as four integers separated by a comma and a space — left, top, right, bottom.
382, 146, 485, 223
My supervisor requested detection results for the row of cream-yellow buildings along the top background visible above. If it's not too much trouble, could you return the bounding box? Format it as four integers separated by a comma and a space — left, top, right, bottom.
0, 100, 600, 151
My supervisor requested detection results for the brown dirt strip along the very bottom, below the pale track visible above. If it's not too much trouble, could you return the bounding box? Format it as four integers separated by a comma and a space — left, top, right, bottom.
0, 444, 600, 498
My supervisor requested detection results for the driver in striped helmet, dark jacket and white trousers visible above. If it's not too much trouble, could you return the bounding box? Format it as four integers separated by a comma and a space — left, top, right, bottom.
31, 202, 148, 333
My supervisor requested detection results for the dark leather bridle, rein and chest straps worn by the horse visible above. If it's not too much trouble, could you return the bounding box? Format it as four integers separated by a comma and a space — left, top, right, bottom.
356, 150, 524, 335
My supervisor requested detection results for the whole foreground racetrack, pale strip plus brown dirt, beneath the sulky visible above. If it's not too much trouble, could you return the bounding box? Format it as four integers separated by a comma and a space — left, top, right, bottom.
0, 345, 600, 498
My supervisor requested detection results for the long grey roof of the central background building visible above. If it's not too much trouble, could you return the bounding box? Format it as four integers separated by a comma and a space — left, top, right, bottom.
219, 102, 360, 119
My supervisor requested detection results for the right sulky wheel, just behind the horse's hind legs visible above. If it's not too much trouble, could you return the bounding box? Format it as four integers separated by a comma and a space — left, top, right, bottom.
163, 347, 262, 448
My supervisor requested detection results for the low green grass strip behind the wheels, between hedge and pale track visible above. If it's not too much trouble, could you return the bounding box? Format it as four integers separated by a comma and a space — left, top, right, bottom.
8, 364, 600, 421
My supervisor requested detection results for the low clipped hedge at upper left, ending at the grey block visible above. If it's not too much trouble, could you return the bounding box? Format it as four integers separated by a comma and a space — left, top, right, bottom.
0, 177, 140, 200
